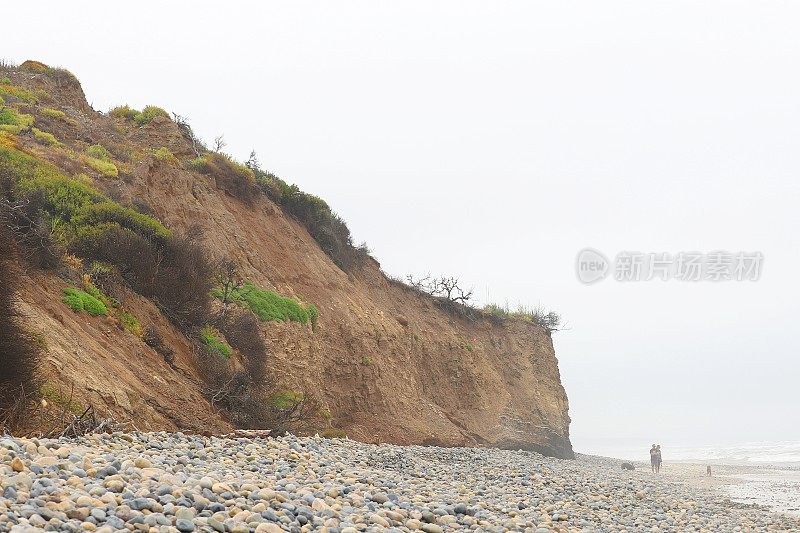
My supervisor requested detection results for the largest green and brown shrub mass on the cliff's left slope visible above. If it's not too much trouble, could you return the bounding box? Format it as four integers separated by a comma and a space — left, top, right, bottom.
0, 131, 213, 331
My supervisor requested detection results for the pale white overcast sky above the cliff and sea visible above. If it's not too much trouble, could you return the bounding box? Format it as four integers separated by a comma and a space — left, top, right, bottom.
7, 0, 800, 453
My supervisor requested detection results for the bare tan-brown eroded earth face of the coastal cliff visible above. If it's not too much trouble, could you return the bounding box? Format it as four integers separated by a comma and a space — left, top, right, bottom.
3, 61, 572, 457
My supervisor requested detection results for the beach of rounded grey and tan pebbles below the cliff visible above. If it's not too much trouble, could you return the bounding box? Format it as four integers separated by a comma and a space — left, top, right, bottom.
0, 433, 800, 533
